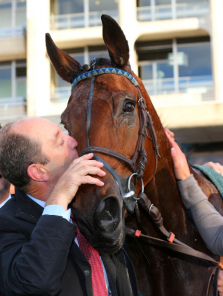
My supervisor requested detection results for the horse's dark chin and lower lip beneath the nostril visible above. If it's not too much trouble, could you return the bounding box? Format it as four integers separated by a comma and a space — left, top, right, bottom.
72, 208, 125, 254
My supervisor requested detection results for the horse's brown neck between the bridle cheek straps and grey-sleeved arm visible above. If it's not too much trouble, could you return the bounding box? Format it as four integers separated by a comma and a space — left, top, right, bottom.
143, 86, 187, 233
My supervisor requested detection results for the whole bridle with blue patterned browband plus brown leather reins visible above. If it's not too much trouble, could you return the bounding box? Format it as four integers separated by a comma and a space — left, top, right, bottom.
72, 62, 223, 296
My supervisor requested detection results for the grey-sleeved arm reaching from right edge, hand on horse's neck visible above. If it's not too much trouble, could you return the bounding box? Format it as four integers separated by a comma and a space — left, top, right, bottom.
167, 134, 223, 256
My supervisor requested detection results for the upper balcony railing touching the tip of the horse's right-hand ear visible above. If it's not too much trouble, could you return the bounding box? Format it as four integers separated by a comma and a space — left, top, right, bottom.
50, 10, 118, 30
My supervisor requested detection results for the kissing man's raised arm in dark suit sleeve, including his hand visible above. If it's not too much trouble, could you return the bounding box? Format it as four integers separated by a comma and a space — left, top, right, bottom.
0, 153, 105, 296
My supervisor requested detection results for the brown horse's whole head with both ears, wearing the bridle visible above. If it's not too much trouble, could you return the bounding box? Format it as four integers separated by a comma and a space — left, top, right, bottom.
46, 15, 157, 253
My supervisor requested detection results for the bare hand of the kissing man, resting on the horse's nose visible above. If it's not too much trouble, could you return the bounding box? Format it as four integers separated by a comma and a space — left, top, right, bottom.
46, 153, 106, 210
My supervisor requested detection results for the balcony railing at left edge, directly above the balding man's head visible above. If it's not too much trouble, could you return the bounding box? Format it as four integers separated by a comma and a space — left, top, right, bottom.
0, 97, 26, 118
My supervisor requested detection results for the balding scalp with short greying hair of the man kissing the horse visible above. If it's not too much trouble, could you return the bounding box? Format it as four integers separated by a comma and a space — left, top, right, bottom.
0, 118, 49, 188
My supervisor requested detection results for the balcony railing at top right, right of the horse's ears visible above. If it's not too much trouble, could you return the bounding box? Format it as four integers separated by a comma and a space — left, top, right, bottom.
137, 2, 210, 22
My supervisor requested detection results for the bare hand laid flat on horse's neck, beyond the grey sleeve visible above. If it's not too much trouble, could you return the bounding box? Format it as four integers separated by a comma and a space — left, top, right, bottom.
166, 132, 190, 180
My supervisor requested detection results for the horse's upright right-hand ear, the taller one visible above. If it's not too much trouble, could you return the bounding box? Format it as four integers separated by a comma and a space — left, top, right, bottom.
101, 14, 129, 68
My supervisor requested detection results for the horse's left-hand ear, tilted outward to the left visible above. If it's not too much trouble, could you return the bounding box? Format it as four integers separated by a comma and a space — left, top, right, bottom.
46, 33, 82, 83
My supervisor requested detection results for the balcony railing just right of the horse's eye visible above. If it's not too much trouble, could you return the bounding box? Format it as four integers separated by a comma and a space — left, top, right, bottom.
143, 76, 213, 95
